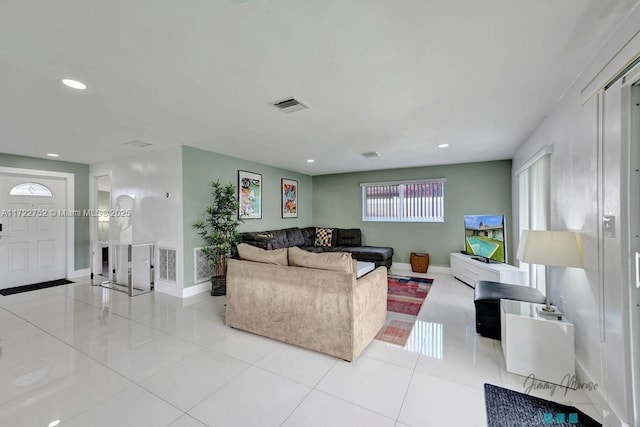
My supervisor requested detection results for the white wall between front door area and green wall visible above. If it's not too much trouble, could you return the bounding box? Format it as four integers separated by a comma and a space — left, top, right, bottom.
91, 147, 184, 297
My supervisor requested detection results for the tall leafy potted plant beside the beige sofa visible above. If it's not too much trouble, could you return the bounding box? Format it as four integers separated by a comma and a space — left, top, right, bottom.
193, 181, 241, 296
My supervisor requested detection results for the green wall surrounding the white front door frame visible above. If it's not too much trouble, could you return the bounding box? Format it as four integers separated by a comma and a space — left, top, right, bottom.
0, 153, 89, 270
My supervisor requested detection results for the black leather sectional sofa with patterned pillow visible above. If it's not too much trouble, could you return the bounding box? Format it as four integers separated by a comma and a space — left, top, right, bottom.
240, 227, 393, 268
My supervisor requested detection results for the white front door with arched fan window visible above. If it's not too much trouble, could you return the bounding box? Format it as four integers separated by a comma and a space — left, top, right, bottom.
0, 174, 66, 289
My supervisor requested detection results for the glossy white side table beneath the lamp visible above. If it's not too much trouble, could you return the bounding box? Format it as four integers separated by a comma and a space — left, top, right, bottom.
500, 299, 575, 386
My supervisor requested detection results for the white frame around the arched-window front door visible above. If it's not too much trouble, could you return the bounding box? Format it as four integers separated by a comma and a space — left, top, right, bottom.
0, 166, 76, 278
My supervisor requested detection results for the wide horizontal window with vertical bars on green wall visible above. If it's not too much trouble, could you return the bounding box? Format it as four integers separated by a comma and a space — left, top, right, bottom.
360, 178, 446, 222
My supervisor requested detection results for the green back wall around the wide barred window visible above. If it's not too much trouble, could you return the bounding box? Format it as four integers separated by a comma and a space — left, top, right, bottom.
313, 160, 513, 266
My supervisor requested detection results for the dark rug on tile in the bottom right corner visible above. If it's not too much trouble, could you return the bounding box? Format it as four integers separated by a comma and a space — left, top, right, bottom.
484, 384, 602, 427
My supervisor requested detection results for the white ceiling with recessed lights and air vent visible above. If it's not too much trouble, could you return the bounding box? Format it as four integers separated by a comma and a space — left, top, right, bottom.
0, 0, 638, 175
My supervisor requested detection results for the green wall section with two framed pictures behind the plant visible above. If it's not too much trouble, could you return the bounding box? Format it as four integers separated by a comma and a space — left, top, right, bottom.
182, 146, 313, 288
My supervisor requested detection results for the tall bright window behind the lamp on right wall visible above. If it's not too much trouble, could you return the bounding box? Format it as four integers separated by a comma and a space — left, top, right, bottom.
516, 146, 551, 294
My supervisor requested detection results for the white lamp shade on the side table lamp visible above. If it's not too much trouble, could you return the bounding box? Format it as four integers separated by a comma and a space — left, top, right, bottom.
516, 230, 582, 268
